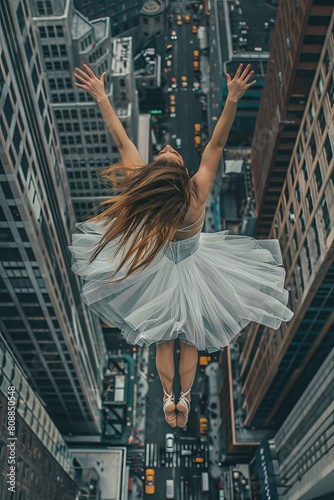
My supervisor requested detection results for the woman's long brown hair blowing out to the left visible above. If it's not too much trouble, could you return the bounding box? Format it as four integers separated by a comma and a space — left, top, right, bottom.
82, 159, 196, 281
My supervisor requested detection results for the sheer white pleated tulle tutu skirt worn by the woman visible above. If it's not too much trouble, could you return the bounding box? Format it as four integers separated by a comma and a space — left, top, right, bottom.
68, 222, 293, 352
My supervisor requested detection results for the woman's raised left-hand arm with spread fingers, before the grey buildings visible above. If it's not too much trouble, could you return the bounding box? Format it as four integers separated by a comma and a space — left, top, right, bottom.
74, 64, 144, 165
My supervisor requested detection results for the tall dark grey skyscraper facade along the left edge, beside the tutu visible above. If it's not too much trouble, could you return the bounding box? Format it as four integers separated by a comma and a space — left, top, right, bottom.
0, 1, 105, 434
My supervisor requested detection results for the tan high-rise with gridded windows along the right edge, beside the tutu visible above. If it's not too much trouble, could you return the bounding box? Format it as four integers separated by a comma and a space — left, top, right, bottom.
240, 7, 334, 427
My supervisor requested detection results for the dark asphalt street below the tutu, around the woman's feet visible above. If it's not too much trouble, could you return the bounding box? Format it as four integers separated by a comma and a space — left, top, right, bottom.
144, 341, 209, 500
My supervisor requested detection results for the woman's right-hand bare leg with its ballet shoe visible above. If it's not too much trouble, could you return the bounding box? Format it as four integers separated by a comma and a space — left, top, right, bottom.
176, 341, 198, 427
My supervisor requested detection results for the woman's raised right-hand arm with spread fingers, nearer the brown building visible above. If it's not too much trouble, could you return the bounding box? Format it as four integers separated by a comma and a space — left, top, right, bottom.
193, 64, 256, 198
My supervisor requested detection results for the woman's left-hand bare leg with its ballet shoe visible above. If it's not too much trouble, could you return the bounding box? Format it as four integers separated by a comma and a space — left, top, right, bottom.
155, 340, 176, 427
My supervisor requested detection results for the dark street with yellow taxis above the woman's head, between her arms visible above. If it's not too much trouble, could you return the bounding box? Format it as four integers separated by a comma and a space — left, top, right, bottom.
166, 2, 203, 175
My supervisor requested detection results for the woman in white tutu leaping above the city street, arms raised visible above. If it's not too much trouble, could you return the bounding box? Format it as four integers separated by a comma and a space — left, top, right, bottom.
69, 64, 293, 427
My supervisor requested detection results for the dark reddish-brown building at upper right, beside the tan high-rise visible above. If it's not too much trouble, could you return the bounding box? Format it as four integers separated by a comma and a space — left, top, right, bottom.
252, 0, 333, 237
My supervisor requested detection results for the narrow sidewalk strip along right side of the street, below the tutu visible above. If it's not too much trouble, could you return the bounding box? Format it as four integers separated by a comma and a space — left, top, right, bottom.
205, 362, 221, 479
